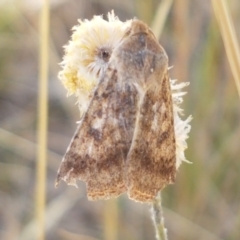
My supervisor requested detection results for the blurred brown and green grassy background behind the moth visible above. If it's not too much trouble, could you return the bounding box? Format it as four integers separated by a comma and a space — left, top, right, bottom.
0, 0, 240, 240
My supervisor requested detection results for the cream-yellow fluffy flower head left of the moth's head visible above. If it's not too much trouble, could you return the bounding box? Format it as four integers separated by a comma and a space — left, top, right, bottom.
58, 11, 131, 115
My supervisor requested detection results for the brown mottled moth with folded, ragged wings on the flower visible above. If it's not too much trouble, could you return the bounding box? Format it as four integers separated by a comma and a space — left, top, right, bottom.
56, 20, 176, 202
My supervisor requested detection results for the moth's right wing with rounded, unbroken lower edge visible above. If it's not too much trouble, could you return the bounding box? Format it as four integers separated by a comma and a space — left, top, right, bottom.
127, 71, 176, 202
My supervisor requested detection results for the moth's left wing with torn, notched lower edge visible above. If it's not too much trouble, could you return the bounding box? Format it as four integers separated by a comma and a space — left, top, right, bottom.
56, 60, 137, 200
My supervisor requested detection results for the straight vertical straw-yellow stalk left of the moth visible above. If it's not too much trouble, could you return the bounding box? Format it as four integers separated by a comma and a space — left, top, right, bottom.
35, 0, 49, 240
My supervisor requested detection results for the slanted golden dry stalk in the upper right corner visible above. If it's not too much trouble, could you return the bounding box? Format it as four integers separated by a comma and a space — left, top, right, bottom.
212, 0, 240, 97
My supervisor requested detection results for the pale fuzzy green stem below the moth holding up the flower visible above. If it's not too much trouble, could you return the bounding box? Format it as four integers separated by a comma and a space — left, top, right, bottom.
152, 192, 168, 240
